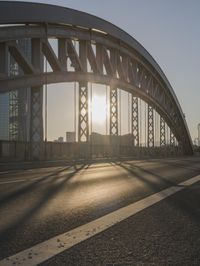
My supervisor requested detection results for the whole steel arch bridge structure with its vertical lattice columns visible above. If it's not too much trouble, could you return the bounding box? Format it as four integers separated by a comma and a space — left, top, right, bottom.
0, 1, 193, 159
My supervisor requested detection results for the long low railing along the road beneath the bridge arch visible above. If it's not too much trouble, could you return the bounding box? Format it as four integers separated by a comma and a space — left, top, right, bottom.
0, 140, 181, 161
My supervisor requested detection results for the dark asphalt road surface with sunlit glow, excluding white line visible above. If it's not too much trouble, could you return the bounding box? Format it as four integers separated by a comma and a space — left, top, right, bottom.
0, 158, 200, 265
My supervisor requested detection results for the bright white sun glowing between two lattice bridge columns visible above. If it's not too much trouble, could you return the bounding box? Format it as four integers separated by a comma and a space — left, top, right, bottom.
91, 95, 106, 124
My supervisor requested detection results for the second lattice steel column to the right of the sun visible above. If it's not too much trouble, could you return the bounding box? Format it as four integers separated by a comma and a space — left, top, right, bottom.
131, 95, 139, 147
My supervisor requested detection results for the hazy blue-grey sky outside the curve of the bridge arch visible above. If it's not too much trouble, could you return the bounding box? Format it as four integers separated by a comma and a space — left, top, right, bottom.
10, 0, 200, 139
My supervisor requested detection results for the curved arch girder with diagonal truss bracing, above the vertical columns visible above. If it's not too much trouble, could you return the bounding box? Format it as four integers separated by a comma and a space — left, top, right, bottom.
0, 3, 192, 154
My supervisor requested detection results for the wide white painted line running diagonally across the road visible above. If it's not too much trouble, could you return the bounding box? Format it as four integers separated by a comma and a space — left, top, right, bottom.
0, 175, 200, 266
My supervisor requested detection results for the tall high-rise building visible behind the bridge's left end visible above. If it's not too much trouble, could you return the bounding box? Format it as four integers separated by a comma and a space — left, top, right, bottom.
0, 39, 31, 141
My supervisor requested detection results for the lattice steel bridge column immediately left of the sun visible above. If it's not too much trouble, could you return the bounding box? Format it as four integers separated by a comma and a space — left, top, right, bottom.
78, 83, 89, 142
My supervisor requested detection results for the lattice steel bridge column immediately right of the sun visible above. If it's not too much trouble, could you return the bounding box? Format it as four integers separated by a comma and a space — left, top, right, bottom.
110, 87, 118, 136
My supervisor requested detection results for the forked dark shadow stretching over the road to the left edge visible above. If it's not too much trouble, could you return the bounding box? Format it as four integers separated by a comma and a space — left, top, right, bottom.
0, 164, 86, 246
